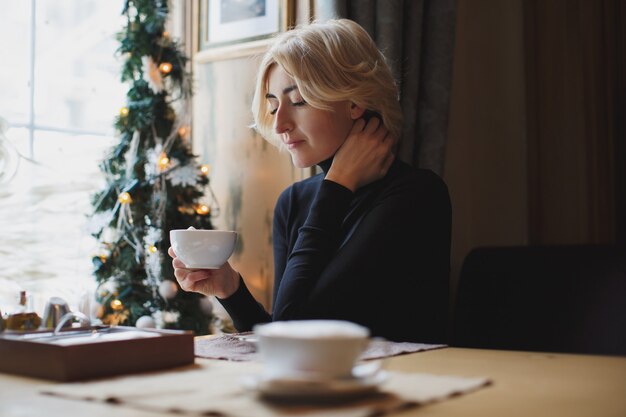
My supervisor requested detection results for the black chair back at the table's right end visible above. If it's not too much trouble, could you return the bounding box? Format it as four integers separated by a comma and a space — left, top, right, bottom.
451, 245, 626, 355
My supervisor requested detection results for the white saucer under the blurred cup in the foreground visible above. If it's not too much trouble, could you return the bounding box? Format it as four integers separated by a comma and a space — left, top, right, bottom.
243, 371, 388, 400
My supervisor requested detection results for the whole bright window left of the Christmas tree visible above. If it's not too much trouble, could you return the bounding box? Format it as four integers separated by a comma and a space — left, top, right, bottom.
0, 0, 126, 313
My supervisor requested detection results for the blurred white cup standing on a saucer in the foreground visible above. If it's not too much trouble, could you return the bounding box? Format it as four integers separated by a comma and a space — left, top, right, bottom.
254, 320, 370, 379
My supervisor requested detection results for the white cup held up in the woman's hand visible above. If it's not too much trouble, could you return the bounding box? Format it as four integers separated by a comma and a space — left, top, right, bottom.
170, 229, 237, 269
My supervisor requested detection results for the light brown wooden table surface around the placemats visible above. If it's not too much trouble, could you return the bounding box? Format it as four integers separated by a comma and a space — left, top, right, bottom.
0, 348, 626, 417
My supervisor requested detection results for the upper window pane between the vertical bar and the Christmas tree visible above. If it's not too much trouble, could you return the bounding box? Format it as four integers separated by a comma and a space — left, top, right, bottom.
35, 0, 127, 134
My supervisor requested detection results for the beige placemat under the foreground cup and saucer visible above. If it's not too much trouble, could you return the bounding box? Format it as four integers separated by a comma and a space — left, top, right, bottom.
40, 359, 490, 417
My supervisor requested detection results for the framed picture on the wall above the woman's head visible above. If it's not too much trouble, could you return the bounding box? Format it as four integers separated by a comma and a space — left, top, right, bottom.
199, 0, 291, 51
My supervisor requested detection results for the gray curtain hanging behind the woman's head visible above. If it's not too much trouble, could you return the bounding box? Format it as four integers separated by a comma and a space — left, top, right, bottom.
313, 0, 456, 175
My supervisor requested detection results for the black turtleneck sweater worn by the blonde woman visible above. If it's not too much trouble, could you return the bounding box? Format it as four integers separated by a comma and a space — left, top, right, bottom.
219, 159, 451, 343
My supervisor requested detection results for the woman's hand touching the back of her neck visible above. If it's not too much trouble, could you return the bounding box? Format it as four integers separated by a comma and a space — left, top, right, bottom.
326, 117, 395, 192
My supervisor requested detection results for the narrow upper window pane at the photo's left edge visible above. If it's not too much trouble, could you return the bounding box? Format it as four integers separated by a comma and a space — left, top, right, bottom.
0, 0, 31, 123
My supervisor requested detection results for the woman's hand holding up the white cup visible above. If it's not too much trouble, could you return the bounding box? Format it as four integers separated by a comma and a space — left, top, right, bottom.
167, 247, 239, 298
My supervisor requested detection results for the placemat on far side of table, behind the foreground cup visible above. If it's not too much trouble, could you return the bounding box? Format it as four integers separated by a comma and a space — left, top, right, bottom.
195, 332, 447, 361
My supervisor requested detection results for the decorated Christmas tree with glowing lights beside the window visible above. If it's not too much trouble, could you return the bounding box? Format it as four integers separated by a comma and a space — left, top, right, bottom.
91, 0, 217, 334
